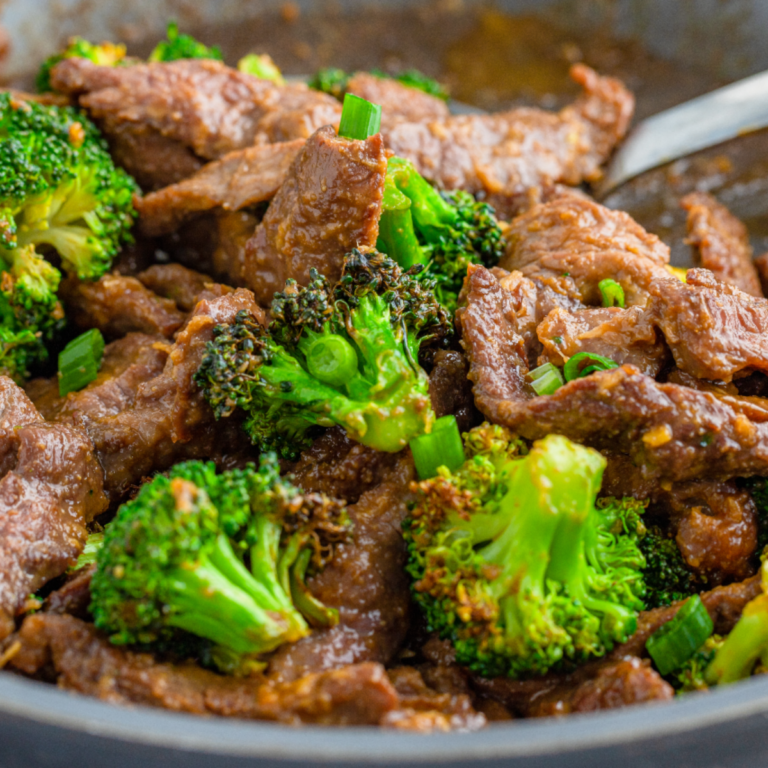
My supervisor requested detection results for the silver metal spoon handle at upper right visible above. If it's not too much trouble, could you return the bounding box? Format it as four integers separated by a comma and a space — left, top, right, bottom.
596, 71, 768, 198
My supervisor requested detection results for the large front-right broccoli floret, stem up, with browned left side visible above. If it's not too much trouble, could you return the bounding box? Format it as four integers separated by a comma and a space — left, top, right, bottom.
404, 424, 645, 677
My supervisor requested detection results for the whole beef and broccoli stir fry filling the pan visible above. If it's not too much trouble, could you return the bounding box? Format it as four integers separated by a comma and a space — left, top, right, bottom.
0, 24, 768, 732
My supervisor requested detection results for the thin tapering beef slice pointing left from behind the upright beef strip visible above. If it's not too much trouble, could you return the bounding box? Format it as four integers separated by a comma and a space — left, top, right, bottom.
136, 139, 304, 237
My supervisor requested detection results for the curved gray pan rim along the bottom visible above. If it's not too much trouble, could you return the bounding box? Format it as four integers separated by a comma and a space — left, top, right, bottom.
0, 673, 768, 766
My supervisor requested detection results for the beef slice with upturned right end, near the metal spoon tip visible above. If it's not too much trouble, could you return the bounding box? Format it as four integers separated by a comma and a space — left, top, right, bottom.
385, 65, 634, 214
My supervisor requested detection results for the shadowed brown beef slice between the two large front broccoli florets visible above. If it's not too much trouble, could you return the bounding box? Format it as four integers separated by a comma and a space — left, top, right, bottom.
269, 452, 414, 680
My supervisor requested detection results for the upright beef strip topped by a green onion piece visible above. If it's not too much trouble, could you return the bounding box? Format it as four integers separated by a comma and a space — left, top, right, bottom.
243, 126, 387, 306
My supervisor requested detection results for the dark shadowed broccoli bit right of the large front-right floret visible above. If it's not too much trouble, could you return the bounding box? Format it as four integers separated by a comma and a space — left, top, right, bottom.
640, 525, 704, 608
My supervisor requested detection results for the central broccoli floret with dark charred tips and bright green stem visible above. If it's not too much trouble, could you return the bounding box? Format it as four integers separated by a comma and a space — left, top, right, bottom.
195, 250, 452, 458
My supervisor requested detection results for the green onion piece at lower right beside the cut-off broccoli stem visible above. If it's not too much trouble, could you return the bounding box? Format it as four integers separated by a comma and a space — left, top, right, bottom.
645, 595, 714, 675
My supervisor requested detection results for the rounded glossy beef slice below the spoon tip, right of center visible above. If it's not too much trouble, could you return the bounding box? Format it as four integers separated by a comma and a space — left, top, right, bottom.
499, 195, 669, 306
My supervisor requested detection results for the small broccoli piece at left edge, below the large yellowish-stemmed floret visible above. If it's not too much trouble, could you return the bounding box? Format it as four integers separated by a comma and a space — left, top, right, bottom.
0, 245, 64, 383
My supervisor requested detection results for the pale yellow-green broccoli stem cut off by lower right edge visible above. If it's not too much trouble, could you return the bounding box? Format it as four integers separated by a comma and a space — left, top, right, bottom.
704, 595, 768, 685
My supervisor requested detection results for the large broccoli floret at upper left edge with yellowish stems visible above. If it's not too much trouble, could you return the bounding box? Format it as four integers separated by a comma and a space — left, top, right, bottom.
0, 93, 138, 280
